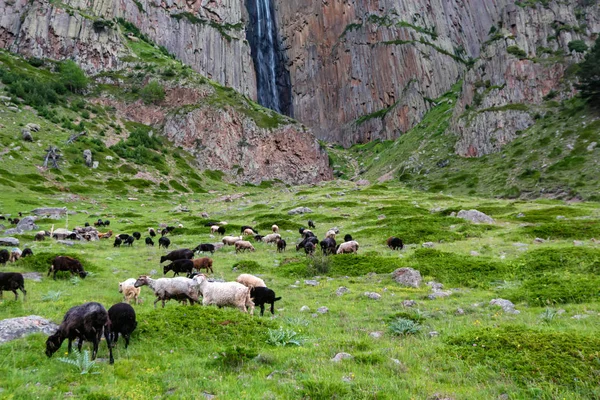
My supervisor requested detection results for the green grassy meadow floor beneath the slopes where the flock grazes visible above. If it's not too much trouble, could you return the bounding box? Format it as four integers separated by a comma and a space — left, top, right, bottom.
0, 181, 600, 399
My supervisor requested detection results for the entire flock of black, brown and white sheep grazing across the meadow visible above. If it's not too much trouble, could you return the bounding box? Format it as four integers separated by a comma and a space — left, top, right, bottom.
0, 219, 403, 364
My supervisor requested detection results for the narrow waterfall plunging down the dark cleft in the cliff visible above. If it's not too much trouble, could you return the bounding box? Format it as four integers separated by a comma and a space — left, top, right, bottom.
246, 0, 292, 115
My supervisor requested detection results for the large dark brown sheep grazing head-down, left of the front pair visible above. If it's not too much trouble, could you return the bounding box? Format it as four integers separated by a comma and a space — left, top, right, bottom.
46, 302, 115, 364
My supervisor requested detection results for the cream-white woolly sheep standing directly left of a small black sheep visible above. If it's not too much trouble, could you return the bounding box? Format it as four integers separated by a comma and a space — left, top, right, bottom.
193, 274, 254, 315
